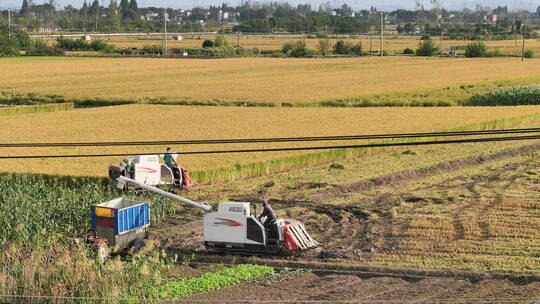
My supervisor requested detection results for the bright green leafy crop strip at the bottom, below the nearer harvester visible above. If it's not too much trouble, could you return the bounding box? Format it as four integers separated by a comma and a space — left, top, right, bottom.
159, 264, 274, 298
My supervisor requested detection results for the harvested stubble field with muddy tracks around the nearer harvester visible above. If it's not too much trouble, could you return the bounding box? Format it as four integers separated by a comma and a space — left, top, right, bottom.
153, 125, 540, 275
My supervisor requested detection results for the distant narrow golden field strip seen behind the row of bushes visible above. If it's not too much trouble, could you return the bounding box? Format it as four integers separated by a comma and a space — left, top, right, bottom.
105, 35, 540, 55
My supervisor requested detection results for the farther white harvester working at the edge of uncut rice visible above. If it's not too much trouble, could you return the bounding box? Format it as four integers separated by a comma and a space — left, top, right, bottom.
109, 155, 195, 190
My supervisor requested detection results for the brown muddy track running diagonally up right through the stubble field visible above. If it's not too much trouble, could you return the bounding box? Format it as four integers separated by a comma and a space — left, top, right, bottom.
311, 143, 540, 203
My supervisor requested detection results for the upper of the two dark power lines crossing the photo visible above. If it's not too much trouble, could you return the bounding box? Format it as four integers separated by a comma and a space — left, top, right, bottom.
0, 128, 540, 148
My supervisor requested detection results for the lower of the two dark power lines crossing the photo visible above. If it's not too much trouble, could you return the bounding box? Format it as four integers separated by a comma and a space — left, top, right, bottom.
0, 135, 540, 159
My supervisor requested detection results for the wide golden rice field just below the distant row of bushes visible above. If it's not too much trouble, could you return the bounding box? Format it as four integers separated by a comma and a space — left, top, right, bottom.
0, 57, 540, 103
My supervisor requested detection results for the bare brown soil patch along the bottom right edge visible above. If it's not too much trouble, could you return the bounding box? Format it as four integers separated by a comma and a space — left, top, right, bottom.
188, 273, 540, 303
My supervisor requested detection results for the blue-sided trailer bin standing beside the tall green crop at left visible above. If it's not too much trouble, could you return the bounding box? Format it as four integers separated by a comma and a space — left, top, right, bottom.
90, 198, 150, 251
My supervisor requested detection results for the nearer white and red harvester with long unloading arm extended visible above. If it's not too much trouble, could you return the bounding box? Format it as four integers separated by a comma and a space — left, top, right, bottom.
117, 176, 320, 255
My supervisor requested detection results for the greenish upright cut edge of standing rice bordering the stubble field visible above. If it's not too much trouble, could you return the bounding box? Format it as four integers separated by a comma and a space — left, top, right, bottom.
191, 114, 540, 183
